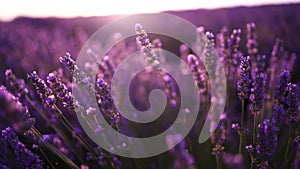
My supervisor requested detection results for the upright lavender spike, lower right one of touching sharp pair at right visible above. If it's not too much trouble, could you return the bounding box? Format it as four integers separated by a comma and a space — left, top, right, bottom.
250, 73, 265, 113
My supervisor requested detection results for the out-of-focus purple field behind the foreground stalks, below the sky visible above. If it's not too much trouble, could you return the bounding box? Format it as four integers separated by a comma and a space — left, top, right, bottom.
0, 4, 300, 80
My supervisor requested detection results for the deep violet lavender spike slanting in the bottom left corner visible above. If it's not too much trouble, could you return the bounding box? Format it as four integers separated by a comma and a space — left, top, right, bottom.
1, 127, 43, 169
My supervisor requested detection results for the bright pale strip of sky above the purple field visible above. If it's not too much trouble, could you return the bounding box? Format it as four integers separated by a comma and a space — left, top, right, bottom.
0, 0, 300, 21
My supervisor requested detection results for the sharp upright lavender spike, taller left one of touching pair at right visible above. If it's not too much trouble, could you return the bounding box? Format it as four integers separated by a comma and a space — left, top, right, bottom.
237, 56, 252, 100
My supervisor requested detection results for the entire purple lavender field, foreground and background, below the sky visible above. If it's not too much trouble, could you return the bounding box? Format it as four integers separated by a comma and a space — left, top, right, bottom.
0, 4, 300, 169
